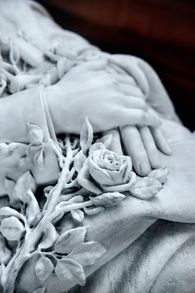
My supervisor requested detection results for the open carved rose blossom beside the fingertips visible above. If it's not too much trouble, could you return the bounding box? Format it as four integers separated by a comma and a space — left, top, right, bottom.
78, 144, 136, 194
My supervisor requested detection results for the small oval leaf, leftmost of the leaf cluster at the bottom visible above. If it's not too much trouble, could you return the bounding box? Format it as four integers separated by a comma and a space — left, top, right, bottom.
35, 256, 54, 282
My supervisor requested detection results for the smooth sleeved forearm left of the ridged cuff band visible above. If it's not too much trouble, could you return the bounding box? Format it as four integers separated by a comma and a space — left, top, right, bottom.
0, 87, 48, 143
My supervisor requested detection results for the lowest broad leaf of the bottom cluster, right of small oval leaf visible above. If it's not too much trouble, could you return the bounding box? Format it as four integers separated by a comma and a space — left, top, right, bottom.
55, 258, 86, 286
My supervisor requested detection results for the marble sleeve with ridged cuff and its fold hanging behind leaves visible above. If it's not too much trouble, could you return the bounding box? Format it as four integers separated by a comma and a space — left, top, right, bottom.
0, 86, 59, 186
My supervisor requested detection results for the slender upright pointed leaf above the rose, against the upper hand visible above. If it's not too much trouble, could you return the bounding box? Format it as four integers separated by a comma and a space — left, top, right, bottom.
80, 117, 93, 153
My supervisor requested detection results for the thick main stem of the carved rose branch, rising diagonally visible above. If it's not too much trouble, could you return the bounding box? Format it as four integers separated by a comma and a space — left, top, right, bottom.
1, 136, 75, 293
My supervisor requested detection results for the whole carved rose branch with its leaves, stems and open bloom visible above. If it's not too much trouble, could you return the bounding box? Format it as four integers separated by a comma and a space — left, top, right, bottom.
0, 115, 167, 293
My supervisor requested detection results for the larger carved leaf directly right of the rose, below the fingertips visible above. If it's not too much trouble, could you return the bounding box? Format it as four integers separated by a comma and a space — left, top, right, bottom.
130, 177, 162, 199
